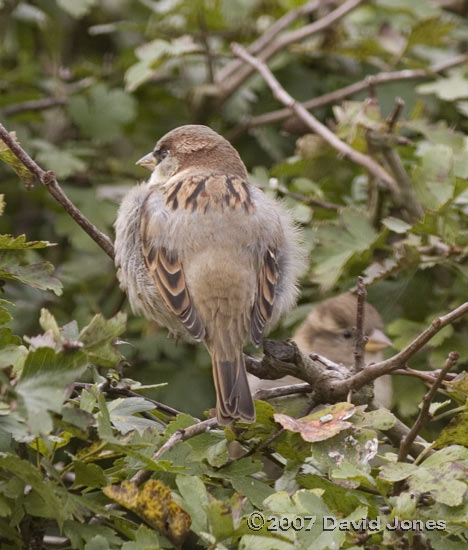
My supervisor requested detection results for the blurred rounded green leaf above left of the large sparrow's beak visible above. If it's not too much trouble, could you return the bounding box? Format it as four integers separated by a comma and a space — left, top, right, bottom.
68, 84, 136, 142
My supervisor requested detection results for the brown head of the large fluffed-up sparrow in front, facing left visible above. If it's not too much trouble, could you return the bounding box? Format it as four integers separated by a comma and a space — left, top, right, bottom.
137, 124, 247, 186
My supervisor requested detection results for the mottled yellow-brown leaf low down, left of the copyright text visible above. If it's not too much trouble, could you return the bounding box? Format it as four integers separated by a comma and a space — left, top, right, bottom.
103, 479, 191, 545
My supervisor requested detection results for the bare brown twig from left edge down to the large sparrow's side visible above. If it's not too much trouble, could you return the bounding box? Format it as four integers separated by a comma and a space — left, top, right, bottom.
0, 124, 114, 259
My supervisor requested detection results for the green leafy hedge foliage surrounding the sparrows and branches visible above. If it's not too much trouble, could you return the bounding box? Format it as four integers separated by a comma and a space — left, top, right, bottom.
0, 0, 468, 550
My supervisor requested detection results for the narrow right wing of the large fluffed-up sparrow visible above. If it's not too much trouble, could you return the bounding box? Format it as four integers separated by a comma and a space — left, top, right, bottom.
250, 248, 279, 346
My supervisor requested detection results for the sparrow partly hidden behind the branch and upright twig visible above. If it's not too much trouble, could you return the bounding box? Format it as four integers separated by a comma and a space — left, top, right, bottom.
249, 292, 392, 408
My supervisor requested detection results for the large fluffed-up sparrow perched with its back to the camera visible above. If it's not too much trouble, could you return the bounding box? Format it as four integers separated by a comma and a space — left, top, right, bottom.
115, 125, 305, 425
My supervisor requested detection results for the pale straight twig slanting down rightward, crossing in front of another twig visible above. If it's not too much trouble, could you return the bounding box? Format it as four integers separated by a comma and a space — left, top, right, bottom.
231, 44, 398, 193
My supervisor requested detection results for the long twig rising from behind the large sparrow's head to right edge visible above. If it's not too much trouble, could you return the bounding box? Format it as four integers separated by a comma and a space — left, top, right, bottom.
228, 54, 468, 141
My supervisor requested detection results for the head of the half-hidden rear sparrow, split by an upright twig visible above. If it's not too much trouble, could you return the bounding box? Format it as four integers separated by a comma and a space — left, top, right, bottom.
293, 292, 391, 366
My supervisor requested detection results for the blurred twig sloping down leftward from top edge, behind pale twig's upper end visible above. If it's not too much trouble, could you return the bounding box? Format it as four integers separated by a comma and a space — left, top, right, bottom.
218, 0, 364, 103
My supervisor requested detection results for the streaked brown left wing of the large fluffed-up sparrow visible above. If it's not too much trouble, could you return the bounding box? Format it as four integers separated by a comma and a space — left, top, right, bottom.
140, 215, 205, 340
